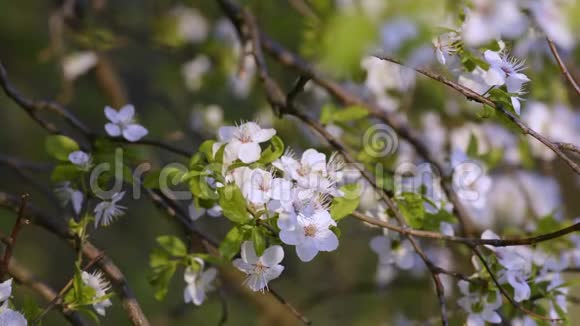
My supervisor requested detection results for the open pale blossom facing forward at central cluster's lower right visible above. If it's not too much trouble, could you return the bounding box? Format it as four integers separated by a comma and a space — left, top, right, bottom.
280, 210, 338, 262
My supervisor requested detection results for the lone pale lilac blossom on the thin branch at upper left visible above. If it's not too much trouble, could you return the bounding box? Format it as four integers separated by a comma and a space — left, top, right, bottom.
105, 104, 149, 142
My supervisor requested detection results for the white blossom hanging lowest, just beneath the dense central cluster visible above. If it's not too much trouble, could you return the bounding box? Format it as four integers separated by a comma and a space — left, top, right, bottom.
232, 241, 284, 291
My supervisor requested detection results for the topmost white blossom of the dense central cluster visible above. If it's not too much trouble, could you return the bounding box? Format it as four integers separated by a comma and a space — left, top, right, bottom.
213, 122, 276, 163
